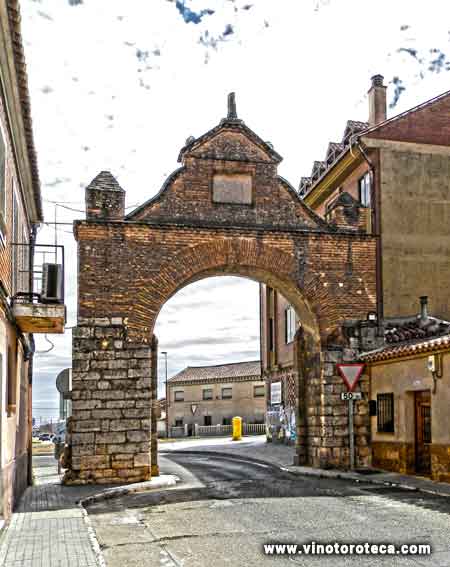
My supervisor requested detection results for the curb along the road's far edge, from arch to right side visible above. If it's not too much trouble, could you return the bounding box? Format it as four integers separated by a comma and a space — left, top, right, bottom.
165, 449, 450, 498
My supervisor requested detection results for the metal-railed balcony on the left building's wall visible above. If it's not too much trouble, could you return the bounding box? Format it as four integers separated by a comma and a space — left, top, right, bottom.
12, 244, 66, 334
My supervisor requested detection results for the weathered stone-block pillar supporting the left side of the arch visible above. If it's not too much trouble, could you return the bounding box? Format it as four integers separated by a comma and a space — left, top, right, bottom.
64, 317, 152, 484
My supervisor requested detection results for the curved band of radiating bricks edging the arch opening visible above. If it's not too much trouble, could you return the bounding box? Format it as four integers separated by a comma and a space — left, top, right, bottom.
130, 236, 316, 340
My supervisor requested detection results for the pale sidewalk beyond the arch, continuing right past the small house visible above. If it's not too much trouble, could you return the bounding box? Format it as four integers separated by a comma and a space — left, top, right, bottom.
159, 435, 450, 496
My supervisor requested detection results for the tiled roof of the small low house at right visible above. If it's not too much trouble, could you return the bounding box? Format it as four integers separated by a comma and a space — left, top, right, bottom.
360, 316, 450, 362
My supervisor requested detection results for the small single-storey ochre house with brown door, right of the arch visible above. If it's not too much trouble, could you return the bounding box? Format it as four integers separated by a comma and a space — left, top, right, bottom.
360, 298, 450, 482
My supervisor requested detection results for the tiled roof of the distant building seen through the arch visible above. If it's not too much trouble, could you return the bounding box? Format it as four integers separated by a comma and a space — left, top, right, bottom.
169, 360, 261, 384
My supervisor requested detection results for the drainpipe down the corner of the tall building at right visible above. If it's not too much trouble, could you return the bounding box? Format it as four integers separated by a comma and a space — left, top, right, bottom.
355, 138, 384, 334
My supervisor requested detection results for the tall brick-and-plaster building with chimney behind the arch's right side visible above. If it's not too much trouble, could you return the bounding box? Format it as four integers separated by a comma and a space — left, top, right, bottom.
261, 75, 450, 458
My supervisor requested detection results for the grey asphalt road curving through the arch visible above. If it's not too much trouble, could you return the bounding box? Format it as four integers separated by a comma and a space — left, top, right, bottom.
88, 453, 450, 567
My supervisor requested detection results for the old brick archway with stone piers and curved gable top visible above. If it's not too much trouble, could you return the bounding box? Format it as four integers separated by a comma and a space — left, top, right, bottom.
65, 100, 376, 483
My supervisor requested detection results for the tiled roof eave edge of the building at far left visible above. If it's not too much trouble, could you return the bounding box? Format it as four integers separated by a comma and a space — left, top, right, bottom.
7, 0, 43, 220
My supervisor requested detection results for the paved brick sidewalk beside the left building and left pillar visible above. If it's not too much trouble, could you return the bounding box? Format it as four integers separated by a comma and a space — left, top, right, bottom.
0, 455, 99, 567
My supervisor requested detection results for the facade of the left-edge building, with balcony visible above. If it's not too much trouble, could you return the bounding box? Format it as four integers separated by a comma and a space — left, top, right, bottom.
0, 0, 65, 523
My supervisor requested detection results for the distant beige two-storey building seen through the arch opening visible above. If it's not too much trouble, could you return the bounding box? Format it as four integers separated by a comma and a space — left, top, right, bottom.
168, 360, 266, 435
